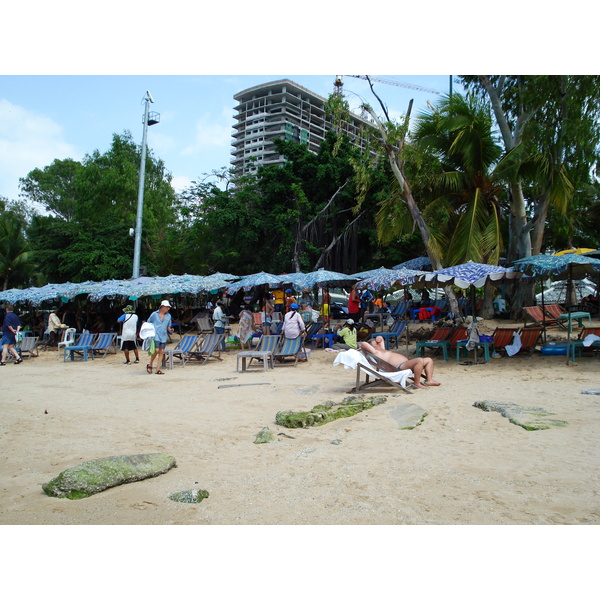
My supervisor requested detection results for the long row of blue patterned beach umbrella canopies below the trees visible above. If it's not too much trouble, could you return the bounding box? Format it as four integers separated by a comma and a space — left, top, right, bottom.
0, 253, 600, 305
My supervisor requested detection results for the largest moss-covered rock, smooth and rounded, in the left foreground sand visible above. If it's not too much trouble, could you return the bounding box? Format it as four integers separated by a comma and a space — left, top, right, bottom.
42, 453, 177, 500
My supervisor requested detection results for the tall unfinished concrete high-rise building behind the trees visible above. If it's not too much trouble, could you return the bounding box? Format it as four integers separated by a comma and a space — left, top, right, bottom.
231, 79, 370, 175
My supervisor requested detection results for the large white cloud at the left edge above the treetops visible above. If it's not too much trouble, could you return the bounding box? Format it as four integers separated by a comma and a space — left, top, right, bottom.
0, 99, 81, 200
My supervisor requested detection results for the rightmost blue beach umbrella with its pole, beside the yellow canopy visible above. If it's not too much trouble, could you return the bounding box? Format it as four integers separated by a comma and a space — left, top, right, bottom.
513, 253, 600, 365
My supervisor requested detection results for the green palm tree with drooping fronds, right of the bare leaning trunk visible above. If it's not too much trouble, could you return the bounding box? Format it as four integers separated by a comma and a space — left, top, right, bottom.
413, 94, 504, 266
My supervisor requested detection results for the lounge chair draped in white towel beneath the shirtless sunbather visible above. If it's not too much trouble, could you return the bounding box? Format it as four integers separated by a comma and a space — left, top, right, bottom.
333, 350, 415, 394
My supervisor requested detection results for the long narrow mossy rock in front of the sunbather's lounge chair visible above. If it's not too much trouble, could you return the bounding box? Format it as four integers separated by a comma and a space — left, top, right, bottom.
275, 394, 387, 429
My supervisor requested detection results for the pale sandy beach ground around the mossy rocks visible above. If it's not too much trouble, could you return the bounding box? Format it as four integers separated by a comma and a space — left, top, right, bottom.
0, 321, 600, 525
